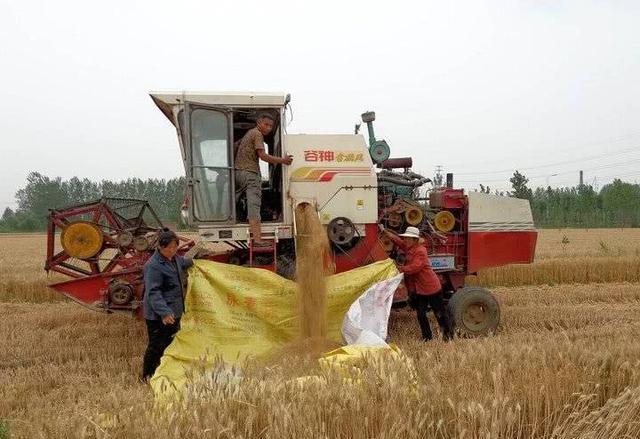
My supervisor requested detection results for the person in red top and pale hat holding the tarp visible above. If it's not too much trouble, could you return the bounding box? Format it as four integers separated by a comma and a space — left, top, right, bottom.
383, 227, 453, 341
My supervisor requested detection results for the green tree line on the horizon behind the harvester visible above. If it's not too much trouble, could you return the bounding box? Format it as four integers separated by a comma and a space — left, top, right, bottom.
0, 171, 640, 232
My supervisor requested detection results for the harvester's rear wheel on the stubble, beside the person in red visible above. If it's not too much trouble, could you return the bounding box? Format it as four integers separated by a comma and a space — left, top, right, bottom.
449, 287, 500, 337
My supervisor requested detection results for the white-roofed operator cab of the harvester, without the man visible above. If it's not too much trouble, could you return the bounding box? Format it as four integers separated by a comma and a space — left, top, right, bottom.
151, 93, 289, 235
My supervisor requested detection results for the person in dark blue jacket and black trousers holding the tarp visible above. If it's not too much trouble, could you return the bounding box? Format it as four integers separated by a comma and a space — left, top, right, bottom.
142, 228, 193, 380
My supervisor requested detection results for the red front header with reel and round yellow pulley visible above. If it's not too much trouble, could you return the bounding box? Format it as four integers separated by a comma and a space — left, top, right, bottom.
45, 198, 193, 312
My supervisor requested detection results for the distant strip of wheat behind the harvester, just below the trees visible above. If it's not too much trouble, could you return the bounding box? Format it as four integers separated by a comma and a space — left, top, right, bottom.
0, 229, 640, 302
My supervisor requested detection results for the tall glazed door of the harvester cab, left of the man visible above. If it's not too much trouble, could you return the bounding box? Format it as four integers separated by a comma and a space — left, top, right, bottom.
185, 103, 235, 224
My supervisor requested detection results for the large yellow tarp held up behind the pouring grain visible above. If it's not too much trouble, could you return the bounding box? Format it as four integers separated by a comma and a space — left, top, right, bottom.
151, 259, 398, 395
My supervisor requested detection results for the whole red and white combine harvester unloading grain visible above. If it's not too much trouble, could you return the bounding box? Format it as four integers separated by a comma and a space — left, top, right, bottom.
46, 92, 537, 335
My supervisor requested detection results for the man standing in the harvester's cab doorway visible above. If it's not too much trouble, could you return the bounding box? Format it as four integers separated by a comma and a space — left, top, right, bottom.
235, 113, 293, 246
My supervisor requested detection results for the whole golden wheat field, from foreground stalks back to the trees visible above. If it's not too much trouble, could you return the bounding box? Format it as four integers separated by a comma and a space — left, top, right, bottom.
0, 230, 640, 439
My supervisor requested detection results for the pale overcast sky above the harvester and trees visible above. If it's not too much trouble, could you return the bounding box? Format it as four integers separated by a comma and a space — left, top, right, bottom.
0, 0, 640, 213
